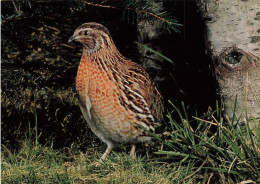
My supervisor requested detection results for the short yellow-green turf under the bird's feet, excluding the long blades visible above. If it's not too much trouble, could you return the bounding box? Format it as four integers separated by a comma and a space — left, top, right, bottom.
2, 136, 173, 183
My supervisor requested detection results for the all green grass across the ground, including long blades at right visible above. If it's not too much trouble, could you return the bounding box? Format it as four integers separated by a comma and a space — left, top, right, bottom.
1, 101, 260, 183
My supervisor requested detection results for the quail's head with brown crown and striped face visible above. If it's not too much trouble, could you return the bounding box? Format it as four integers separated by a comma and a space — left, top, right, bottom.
69, 22, 113, 54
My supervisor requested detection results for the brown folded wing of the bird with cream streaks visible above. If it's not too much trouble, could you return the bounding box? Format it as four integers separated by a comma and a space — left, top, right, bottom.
116, 60, 163, 130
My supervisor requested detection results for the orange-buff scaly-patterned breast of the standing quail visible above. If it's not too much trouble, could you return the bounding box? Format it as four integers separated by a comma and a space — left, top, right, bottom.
76, 57, 134, 126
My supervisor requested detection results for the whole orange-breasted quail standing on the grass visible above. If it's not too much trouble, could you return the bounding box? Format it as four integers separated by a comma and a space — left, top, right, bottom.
68, 22, 164, 160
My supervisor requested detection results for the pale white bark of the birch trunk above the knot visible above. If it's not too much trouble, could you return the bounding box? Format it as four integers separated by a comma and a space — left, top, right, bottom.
200, 0, 260, 56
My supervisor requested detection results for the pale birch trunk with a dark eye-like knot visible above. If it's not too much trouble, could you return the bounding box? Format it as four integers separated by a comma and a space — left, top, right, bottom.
198, 0, 260, 128
